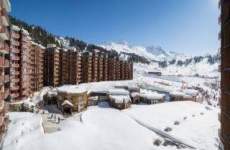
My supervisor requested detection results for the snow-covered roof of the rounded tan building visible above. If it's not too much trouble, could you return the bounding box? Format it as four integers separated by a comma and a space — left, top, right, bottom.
57, 85, 87, 94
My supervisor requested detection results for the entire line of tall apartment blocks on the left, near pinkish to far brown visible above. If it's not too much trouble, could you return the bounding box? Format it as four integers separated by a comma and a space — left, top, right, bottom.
0, 0, 133, 142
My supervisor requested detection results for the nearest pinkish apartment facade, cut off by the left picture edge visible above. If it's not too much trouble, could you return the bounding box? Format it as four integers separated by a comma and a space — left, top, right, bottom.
0, 0, 11, 140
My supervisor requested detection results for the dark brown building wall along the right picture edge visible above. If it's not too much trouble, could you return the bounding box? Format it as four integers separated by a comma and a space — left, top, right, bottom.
220, 0, 230, 150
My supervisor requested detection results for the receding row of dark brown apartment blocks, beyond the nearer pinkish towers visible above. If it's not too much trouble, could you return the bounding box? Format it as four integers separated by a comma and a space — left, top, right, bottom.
44, 44, 133, 87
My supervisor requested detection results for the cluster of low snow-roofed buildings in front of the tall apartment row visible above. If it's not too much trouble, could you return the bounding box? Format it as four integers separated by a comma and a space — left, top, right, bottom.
43, 82, 199, 114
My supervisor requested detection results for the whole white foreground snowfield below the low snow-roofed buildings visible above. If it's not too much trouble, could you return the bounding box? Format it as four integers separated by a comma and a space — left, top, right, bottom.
3, 102, 219, 150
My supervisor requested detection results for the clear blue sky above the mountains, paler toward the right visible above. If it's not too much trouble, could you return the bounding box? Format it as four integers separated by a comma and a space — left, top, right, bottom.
11, 0, 219, 55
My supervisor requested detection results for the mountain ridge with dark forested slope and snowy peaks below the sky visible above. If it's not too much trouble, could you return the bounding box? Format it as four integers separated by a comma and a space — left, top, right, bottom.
10, 16, 220, 68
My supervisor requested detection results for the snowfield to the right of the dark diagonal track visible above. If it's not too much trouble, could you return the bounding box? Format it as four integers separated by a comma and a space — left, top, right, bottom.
124, 101, 220, 150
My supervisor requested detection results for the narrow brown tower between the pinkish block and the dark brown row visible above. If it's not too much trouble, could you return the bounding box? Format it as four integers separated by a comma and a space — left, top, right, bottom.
30, 42, 45, 92
